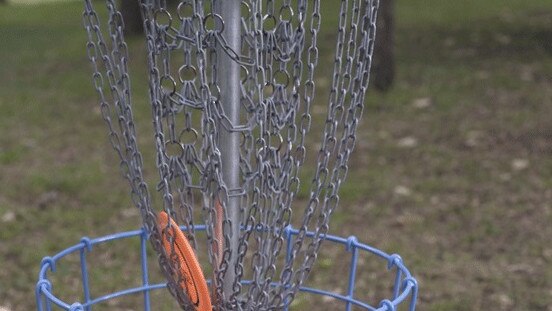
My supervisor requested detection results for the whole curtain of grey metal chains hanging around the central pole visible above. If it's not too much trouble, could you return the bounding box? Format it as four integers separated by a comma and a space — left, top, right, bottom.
83, 0, 378, 310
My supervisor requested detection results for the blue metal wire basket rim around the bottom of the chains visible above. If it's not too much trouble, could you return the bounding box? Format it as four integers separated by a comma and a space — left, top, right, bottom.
35, 226, 418, 311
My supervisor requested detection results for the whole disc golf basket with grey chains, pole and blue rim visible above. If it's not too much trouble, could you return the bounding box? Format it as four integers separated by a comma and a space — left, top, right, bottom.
36, 0, 417, 311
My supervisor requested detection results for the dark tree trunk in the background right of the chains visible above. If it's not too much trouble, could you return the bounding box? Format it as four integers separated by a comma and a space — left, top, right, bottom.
372, 0, 395, 91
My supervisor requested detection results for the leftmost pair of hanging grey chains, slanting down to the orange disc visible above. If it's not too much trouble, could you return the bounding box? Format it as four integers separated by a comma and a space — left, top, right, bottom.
83, 0, 196, 310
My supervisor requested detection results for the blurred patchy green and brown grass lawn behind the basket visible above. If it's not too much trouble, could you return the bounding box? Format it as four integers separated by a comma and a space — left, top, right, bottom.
0, 0, 552, 311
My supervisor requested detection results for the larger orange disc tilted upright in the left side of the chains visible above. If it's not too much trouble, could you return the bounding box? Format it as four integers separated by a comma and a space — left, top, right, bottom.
157, 211, 212, 311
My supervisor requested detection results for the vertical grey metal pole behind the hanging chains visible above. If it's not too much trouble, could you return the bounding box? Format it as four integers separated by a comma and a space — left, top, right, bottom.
214, 0, 241, 299
